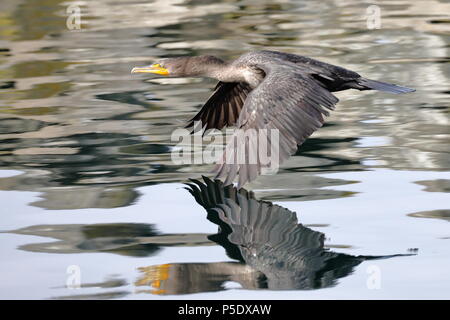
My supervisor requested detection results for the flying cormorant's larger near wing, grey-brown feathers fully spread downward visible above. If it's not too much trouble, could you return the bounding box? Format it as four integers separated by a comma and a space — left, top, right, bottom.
214, 61, 338, 187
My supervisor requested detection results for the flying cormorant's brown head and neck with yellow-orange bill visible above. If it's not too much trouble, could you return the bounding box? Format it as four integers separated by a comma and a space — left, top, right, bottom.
131, 56, 224, 77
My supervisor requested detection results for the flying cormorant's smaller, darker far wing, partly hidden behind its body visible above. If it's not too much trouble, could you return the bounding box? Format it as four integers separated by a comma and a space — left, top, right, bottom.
186, 82, 251, 131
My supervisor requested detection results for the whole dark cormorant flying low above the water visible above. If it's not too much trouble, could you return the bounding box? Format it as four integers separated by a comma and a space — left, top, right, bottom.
132, 50, 414, 186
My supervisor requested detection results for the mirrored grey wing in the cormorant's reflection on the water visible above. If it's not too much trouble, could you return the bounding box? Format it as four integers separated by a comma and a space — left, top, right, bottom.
186, 177, 325, 266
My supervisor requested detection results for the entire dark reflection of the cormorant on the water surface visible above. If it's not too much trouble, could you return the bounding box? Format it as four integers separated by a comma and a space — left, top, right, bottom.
135, 178, 403, 294
